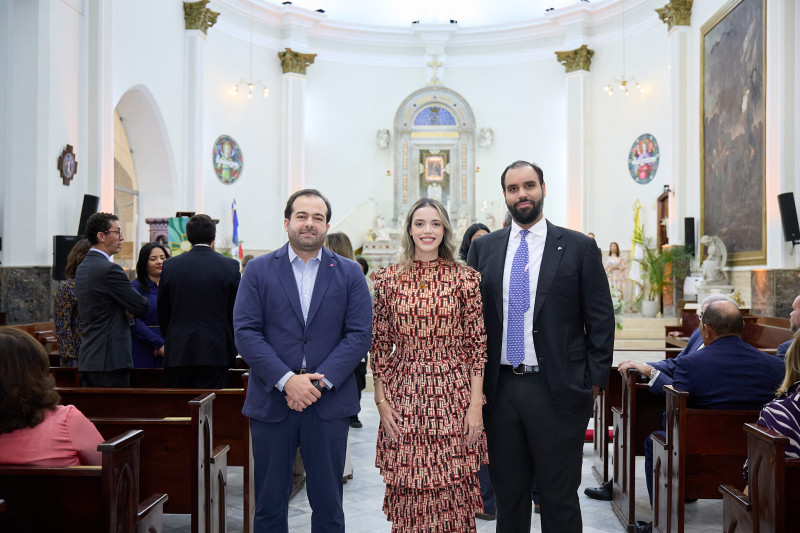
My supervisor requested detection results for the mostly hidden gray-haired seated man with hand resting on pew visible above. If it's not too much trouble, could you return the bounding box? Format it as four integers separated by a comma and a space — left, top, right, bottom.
583, 294, 736, 501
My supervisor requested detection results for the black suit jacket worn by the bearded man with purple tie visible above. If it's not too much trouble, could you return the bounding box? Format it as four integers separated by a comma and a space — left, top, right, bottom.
467, 222, 614, 416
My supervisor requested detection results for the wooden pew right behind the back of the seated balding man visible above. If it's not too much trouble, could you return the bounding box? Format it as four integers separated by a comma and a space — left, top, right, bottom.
653, 385, 759, 533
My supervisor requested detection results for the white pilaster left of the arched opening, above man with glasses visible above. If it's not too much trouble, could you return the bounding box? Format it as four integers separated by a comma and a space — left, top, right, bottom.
86, 0, 114, 213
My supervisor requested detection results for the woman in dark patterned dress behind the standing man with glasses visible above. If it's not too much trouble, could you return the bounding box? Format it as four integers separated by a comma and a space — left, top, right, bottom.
53, 239, 92, 366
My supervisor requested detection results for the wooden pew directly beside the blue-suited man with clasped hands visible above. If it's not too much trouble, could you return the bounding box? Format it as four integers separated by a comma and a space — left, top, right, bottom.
56, 387, 255, 531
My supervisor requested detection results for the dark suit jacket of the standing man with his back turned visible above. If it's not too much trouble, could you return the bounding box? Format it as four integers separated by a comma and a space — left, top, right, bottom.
158, 246, 241, 368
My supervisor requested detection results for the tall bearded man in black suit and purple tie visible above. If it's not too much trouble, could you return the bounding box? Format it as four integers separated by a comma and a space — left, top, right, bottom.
467, 161, 614, 533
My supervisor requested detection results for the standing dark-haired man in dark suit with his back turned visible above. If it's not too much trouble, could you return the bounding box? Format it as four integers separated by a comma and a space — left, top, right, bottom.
158, 215, 240, 389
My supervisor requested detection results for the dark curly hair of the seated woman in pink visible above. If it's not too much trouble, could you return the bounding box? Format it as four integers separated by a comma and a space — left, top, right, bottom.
0, 326, 61, 434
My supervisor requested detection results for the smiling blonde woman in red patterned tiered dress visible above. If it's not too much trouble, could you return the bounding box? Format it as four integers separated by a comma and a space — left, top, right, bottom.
371, 198, 487, 533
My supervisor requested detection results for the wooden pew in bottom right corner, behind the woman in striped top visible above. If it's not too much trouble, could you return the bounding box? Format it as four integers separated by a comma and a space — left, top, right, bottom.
719, 424, 800, 533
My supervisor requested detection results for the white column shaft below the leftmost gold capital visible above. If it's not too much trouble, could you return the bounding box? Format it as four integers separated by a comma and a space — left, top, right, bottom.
182, 30, 207, 213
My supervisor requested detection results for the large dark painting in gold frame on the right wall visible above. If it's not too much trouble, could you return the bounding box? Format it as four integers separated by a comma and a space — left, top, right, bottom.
700, 0, 767, 266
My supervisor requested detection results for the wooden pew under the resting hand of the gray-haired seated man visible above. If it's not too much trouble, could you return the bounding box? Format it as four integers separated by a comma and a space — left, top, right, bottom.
611, 370, 664, 532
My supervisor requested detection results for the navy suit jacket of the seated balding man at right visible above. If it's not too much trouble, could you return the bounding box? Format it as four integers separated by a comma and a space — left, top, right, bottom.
672, 337, 784, 409
